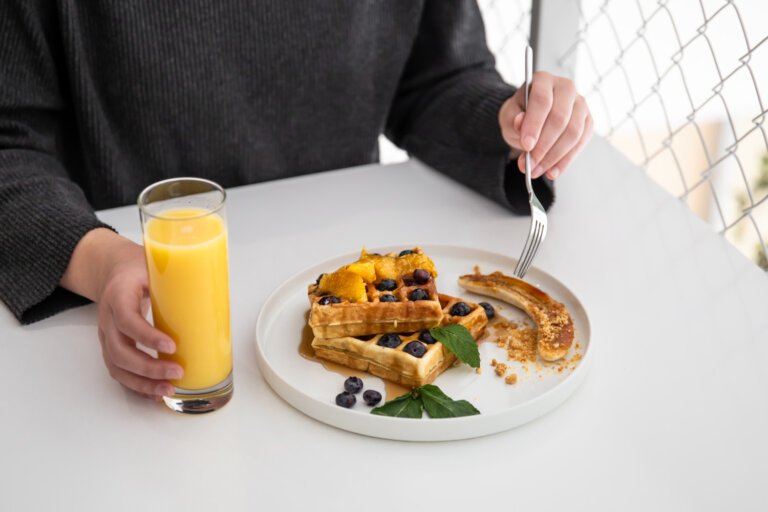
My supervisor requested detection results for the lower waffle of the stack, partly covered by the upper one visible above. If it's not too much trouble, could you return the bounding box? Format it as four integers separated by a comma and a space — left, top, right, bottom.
312, 294, 488, 387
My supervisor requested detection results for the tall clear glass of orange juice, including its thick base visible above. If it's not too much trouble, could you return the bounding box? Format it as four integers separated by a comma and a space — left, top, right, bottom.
138, 178, 233, 413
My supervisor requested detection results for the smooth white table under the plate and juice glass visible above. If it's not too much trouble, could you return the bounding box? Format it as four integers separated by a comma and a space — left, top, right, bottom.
0, 139, 768, 511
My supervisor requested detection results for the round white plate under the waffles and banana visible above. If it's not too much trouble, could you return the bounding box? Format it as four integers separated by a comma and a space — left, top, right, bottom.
256, 245, 593, 441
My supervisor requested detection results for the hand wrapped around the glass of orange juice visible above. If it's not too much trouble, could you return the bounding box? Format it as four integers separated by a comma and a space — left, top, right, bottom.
61, 229, 184, 400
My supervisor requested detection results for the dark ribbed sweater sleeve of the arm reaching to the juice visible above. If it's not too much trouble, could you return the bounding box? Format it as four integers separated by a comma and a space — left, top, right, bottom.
0, 0, 112, 323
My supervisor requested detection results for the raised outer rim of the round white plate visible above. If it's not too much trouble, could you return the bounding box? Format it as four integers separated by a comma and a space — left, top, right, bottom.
254, 244, 594, 441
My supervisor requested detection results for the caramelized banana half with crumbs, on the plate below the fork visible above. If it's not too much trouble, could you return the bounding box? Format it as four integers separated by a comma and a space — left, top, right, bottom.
459, 272, 573, 361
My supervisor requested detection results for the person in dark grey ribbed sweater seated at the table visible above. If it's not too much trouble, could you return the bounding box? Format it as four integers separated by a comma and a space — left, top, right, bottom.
0, 0, 592, 398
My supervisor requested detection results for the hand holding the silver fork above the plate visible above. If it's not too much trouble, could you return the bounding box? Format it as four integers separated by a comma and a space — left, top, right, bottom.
499, 71, 592, 180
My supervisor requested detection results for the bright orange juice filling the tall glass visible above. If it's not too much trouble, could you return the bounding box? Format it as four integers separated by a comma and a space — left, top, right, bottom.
144, 208, 232, 390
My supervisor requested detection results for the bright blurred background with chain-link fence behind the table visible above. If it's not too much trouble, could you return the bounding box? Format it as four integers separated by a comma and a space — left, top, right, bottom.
381, 0, 768, 271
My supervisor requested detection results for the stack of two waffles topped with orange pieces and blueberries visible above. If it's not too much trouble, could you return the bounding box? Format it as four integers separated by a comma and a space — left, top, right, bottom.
308, 247, 488, 387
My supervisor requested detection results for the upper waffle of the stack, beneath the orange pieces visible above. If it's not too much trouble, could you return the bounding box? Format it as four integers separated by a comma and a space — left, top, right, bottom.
307, 248, 443, 338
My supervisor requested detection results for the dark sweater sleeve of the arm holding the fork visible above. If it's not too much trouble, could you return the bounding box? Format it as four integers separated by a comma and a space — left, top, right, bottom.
386, 0, 554, 214
